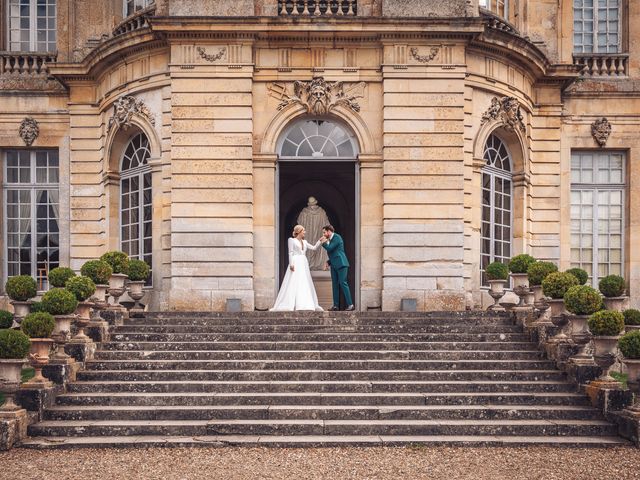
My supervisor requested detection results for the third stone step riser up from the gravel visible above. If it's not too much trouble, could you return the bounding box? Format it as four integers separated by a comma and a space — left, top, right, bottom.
45, 406, 600, 421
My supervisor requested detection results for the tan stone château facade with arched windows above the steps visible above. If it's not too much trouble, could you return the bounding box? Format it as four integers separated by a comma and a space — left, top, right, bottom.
0, 0, 640, 310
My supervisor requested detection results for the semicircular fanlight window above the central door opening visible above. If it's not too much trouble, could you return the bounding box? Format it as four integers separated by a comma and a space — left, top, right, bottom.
280, 120, 358, 160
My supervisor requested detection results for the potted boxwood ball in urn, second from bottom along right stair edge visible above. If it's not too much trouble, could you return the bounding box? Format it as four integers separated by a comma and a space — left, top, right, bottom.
589, 310, 624, 386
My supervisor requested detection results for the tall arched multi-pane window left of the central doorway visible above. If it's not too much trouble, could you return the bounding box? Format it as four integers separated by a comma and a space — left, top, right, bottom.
120, 133, 152, 283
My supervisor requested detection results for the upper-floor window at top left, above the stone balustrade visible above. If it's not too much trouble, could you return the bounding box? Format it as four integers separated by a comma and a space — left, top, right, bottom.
7, 0, 57, 52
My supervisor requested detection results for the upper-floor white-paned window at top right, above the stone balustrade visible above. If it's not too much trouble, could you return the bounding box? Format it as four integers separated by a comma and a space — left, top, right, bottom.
573, 0, 622, 53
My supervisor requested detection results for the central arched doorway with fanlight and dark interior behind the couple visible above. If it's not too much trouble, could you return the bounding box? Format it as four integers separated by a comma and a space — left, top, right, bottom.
276, 118, 359, 308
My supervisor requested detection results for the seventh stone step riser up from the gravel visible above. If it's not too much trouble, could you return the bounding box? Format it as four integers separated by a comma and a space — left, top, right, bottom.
86, 359, 554, 371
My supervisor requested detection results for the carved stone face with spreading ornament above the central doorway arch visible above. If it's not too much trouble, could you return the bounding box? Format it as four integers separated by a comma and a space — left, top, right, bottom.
270, 77, 366, 115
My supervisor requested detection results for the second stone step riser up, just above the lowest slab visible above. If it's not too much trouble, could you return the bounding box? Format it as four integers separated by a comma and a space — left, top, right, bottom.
29, 421, 617, 437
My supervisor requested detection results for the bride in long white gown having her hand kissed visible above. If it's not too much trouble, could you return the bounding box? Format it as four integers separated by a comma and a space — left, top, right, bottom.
271, 225, 322, 312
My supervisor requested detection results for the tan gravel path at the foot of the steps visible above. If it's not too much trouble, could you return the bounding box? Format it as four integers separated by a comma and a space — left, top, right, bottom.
0, 447, 640, 480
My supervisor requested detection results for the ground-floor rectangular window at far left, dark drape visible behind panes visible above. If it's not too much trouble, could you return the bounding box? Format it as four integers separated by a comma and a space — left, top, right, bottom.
3, 150, 60, 290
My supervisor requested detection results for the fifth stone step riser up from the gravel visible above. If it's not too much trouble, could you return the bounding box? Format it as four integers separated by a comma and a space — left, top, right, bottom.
68, 382, 576, 395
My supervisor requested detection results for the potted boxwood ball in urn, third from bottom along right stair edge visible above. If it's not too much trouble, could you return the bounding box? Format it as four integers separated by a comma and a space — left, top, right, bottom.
564, 285, 602, 362
